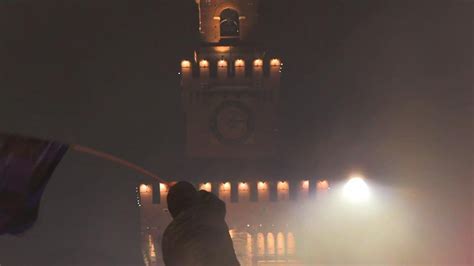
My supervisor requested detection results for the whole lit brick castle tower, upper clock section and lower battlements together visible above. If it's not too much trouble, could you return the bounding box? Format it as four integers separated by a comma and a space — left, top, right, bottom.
137, 0, 329, 265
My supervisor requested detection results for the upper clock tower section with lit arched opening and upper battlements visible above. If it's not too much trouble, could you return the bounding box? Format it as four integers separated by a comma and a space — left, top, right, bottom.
180, 0, 281, 159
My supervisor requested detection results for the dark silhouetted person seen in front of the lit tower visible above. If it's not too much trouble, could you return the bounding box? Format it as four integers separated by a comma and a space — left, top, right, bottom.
162, 182, 240, 266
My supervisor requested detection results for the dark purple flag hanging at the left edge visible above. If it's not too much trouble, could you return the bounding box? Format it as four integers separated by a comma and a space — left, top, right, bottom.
0, 133, 68, 235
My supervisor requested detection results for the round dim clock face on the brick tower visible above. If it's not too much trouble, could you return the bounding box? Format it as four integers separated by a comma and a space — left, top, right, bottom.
210, 101, 254, 144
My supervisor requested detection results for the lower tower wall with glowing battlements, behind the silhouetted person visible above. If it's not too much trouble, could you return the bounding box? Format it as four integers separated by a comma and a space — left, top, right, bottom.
137, 179, 330, 265
